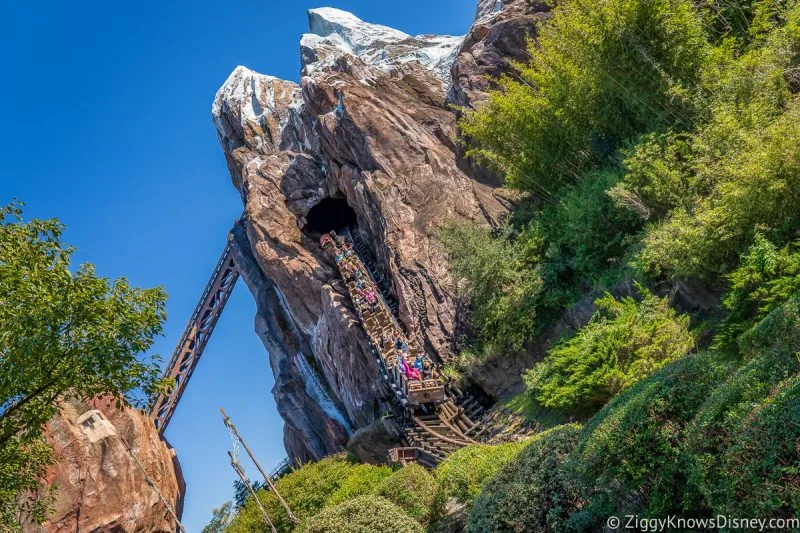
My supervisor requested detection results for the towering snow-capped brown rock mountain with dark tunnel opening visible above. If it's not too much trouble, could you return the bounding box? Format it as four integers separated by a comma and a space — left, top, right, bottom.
212, 0, 546, 462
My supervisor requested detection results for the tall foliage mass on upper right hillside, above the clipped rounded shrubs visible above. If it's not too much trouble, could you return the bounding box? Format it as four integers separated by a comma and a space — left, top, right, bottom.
442, 0, 800, 344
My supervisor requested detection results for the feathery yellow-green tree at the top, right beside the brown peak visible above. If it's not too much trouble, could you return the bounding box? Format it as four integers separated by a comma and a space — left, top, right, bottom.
461, 0, 708, 193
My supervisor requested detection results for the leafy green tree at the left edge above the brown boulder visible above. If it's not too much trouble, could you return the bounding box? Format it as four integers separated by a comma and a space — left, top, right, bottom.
0, 203, 166, 519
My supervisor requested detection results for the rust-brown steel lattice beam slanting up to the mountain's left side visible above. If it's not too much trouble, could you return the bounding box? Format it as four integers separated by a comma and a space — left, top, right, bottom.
150, 246, 239, 435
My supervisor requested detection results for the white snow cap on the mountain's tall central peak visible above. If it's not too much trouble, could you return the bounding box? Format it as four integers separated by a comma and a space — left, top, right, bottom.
300, 7, 464, 81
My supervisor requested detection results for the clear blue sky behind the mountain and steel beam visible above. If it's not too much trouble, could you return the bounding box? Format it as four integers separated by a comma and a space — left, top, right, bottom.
0, 0, 475, 532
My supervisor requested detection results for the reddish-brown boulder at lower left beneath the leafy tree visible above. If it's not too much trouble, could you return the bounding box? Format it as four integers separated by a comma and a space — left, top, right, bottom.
23, 400, 185, 533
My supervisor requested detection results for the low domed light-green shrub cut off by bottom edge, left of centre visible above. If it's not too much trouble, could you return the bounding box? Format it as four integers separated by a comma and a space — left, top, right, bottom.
298, 496, 424, 533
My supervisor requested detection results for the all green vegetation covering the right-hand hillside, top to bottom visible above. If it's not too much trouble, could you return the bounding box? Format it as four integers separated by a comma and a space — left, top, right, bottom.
441, 0, 800, 531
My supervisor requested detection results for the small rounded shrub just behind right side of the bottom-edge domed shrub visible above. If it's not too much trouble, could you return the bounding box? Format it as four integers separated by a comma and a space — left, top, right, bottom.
373, 464, 436, 526
